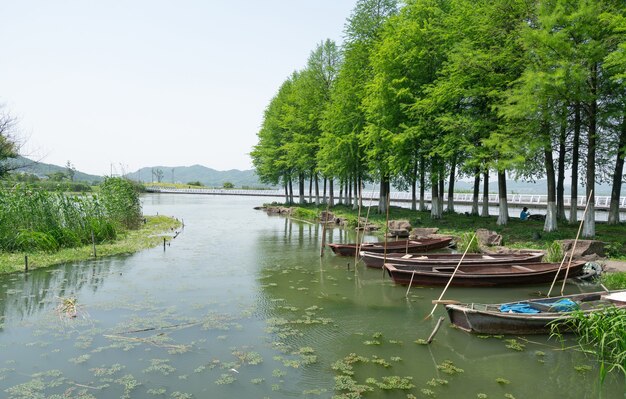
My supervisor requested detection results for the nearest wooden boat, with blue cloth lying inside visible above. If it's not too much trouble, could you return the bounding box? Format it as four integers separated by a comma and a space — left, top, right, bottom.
446, 290, 626, 334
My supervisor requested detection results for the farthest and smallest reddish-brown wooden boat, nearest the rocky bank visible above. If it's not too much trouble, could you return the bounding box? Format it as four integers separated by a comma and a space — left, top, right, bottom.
328, 237, 452, 256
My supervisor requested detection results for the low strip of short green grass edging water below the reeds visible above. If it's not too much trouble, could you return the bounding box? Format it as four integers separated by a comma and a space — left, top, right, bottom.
0, 216, 181, 274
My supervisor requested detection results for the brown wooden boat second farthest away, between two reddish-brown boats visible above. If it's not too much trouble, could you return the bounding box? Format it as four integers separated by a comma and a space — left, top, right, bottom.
359, 250, 544, 269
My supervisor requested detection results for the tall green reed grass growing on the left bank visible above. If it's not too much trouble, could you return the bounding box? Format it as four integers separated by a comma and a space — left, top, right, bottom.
0, 178, 141, 252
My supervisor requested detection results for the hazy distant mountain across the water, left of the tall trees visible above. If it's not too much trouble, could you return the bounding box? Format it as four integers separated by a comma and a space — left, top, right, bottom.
126, 165, 267, 188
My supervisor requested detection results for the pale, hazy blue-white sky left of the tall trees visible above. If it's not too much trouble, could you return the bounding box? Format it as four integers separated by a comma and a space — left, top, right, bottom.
0, 0, 356, 175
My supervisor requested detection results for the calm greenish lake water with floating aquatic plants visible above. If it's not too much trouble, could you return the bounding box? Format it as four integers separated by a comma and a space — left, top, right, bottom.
0, 195, 624, 399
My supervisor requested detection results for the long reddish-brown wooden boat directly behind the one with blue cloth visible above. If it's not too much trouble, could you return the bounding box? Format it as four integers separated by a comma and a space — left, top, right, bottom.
383, 262, 585, 287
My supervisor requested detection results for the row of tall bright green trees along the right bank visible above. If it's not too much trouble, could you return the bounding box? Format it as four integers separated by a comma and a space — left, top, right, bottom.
251, 0, 626, 237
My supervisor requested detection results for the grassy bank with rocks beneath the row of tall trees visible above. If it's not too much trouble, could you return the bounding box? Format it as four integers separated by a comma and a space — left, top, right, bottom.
284, 204, 626, 260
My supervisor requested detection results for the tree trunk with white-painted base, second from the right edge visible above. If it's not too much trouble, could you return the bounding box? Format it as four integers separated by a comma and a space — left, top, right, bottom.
582, 64, 598, 238
